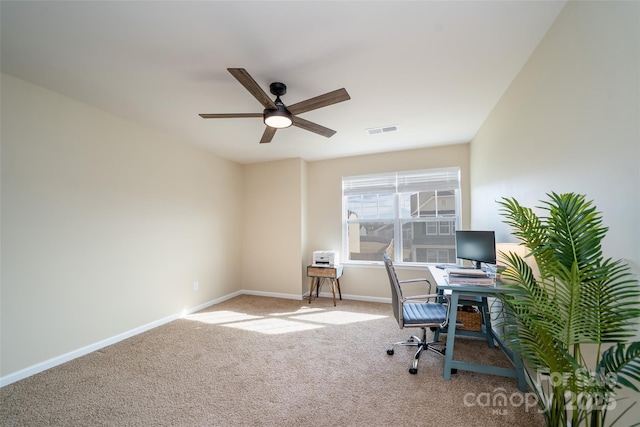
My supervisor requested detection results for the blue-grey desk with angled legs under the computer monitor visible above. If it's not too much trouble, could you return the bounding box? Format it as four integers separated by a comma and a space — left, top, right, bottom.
429, 267, 527, 392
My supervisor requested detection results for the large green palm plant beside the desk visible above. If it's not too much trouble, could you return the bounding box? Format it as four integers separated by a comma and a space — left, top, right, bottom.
498, 193, 640, 427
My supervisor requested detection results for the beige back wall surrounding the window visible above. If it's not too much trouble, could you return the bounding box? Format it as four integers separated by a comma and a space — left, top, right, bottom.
304, 144, 470, 300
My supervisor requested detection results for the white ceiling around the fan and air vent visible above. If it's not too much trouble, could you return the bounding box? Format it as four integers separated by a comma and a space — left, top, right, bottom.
0, 0, 565, 163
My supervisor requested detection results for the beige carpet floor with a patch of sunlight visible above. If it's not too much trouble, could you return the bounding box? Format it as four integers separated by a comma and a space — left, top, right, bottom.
0, 295, 544, 427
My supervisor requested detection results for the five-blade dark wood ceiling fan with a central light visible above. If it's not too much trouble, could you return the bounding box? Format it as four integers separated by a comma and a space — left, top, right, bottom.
200, 68, 351, 144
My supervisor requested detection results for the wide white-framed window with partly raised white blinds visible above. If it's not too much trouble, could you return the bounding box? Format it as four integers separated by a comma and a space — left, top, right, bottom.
342, 168, 460, 263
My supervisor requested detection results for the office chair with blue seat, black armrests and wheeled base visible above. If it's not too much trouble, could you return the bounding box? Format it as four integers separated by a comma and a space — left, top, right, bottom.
382, 253, 453, 374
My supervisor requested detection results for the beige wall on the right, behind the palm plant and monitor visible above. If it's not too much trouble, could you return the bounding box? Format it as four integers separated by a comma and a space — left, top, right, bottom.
471, 1, 640, 425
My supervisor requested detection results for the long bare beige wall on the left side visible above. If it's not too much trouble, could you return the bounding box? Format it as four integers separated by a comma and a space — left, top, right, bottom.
0, 74, 245, 376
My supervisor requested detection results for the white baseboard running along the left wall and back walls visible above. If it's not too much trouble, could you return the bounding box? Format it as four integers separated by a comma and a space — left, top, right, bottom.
0, 290, 391, 388
